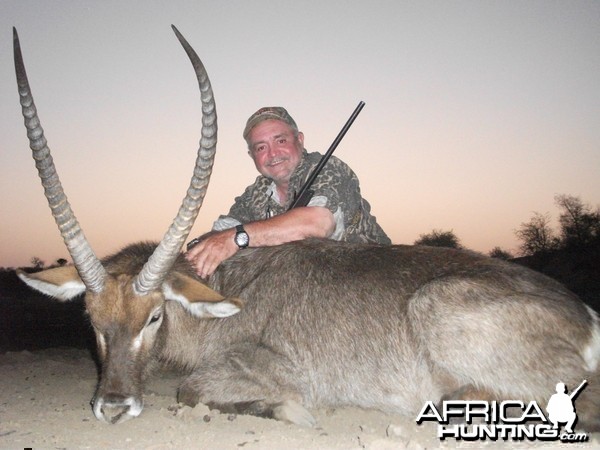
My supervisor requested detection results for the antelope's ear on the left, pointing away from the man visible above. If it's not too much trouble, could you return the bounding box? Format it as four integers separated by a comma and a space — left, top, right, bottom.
17, 266, 85, 301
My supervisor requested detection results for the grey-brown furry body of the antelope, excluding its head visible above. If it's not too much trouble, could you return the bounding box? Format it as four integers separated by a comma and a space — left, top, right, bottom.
90, 240, 600, 428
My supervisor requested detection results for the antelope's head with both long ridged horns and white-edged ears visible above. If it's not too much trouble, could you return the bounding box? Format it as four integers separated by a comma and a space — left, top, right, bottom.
13, 27, 241, 423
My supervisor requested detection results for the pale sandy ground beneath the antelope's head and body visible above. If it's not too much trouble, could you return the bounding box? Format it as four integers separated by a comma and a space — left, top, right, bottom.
0, 348, 600, 449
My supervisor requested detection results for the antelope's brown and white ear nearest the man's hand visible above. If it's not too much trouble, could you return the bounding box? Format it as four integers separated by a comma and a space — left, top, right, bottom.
162, 272, 243, 318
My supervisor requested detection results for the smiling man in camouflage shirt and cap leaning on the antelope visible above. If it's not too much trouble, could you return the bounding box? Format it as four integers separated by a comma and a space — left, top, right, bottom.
186, 107, 391, 278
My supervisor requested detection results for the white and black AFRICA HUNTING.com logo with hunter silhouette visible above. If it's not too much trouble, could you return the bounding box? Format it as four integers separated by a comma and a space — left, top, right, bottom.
416, 380, 589, 442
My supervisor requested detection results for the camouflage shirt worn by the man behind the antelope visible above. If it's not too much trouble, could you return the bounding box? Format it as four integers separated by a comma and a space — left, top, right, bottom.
213, 150, 391, 244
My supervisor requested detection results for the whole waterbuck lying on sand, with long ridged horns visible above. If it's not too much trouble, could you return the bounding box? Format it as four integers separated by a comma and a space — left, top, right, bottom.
15, 30, 600, 430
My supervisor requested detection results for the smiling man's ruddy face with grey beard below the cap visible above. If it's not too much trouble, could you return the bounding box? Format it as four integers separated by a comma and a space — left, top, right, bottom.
248, 119, 304, 185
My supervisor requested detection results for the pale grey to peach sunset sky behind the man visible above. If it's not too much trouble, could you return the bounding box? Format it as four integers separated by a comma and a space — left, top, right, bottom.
0, 0, 600, 267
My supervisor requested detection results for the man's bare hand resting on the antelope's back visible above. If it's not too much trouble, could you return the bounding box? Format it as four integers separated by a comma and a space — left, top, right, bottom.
185, 229, 238, 279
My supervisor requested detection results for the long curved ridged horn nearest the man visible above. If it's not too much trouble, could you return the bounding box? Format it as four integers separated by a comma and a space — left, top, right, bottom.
133, 25, 217, 295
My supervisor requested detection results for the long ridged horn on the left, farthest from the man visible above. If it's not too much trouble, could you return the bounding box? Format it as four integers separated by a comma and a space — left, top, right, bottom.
13, 27, 106, 292
